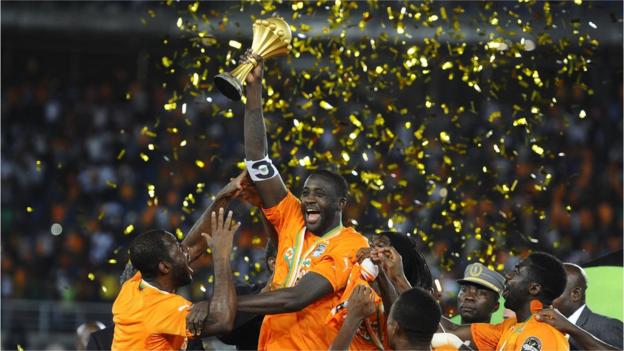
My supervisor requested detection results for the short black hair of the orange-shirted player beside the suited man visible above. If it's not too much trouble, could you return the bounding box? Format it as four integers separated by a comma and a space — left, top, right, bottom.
527, 252, 567, 304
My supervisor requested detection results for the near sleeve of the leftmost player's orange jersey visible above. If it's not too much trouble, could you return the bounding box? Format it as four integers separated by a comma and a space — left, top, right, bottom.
150, 295, 191, 336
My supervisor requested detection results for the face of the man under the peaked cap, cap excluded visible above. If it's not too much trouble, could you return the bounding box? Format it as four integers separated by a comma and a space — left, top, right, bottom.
457, 283, 498, 323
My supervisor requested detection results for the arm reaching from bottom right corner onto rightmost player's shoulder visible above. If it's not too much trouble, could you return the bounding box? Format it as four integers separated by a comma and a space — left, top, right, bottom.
535, 308, 619, 350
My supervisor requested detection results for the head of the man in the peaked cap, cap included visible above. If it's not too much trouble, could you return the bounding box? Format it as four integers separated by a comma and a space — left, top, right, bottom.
457, 262, 505, 324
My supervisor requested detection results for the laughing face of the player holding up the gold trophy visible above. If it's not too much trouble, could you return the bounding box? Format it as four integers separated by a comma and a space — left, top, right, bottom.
301, 176, 342, 235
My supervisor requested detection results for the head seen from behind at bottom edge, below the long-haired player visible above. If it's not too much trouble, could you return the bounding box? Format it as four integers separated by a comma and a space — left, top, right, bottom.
388, 288, 442, 350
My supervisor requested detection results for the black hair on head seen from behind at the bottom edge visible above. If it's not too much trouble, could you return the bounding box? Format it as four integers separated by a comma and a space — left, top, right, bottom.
392, 288, 442, 344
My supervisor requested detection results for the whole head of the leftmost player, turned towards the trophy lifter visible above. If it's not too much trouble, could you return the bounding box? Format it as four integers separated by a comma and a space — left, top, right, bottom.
130, 229, 193, 287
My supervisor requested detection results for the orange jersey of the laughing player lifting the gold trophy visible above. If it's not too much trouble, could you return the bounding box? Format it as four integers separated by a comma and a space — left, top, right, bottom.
258, 192, 368, 350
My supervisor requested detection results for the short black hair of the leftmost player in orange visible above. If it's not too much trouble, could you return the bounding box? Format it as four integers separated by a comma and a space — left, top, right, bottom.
130, 229, 171, 278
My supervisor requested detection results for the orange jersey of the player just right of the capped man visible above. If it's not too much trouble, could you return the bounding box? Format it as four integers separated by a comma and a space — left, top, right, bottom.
470, 316, 570, 351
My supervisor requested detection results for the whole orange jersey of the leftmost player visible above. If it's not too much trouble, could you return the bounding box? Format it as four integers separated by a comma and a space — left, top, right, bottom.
112, 273, 191, 350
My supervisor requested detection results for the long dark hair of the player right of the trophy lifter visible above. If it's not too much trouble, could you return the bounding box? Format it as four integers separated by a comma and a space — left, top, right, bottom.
378, 232, 433, 290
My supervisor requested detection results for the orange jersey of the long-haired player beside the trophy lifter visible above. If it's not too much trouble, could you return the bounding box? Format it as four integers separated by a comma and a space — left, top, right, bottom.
328, 263, 390, 350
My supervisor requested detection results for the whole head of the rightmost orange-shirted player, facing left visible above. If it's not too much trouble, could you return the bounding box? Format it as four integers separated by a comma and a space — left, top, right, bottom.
503, 252, 567, 311
